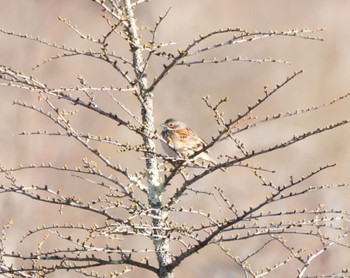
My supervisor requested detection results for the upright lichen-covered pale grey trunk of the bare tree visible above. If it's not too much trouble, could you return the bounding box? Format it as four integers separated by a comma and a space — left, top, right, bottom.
123, 0, 173, 278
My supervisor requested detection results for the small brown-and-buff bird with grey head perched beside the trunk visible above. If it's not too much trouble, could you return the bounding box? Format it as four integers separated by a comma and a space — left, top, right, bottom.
161, 118, 217, 169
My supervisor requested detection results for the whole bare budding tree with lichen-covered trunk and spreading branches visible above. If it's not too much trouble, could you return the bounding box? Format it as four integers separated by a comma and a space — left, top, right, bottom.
0, 0, 349, 277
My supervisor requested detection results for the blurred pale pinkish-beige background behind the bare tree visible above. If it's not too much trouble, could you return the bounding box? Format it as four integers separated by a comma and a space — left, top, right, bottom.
0, 0, 350, 277
